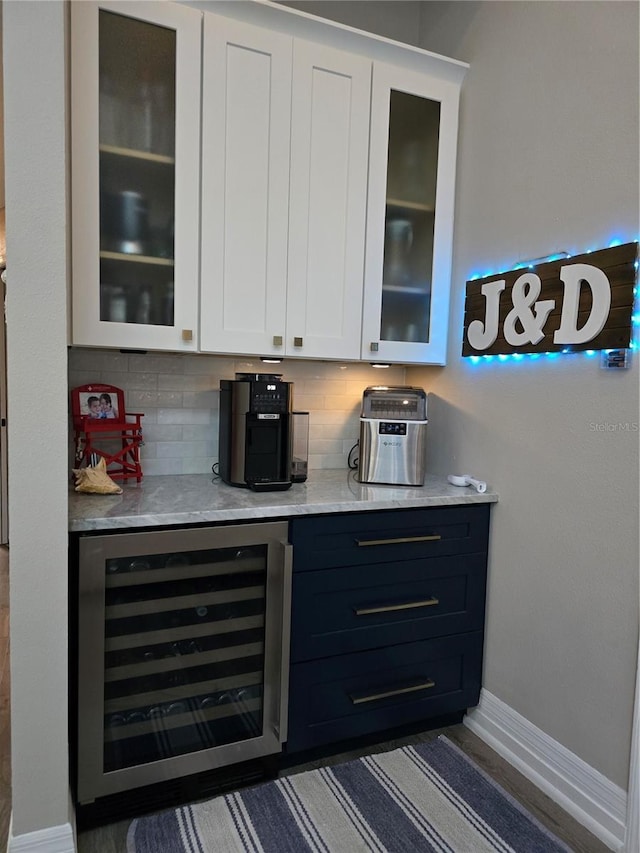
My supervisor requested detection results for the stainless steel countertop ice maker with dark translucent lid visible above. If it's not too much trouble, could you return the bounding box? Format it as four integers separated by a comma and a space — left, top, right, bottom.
358, 385, 428, 486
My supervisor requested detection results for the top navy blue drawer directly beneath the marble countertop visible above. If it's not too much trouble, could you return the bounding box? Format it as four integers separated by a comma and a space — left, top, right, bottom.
290, 504, 489, 572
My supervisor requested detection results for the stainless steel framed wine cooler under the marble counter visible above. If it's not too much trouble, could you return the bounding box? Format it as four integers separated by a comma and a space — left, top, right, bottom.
77, 522, 291, 804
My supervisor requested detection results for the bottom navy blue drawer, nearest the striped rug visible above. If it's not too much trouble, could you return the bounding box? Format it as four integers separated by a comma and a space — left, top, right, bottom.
287, 631, 483, 753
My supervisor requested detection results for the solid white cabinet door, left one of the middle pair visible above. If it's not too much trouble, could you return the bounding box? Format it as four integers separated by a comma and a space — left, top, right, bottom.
200, 14, 292, 355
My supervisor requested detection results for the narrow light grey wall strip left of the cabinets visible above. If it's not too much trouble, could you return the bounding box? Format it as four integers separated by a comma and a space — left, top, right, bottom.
3, 2, 69, 849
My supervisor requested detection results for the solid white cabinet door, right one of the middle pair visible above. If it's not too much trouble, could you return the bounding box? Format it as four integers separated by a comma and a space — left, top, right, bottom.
286, 39, 371, 359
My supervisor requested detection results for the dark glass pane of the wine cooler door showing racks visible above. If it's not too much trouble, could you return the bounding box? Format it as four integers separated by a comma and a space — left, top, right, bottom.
104, 545, 267, 772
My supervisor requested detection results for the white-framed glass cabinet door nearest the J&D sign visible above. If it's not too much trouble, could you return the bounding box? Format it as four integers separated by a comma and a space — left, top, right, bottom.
362, 63, 459, 364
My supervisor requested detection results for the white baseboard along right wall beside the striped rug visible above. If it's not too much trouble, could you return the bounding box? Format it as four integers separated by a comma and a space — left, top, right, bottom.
464, 690, 627, 851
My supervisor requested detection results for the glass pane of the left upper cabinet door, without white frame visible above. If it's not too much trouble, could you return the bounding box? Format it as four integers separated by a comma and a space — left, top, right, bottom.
99, 10, 176, 326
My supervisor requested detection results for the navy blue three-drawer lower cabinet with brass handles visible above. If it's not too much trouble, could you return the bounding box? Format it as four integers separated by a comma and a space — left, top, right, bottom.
286, 504, 489, 753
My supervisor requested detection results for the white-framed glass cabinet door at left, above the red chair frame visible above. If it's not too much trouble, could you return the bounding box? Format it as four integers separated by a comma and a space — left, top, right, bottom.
71, 2, 201, 350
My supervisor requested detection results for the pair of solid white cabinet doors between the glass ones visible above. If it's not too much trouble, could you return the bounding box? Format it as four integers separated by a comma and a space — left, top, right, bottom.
200, 14, 371, 359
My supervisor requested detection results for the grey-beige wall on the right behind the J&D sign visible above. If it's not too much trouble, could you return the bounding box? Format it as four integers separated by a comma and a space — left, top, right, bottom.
407, 2, 640, 790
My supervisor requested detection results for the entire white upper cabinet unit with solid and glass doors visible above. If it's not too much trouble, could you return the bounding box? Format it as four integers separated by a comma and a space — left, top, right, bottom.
71, 0, 467, 364
